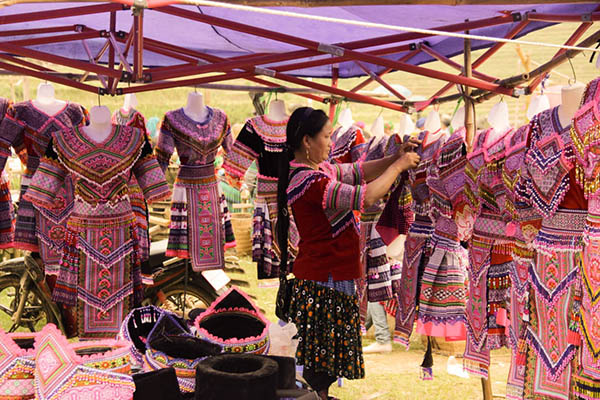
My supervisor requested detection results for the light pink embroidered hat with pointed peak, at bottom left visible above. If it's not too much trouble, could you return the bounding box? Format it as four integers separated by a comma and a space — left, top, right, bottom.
35, 324, 135, 400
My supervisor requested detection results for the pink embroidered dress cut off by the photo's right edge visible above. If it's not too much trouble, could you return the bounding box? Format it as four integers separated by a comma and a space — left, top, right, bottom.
571, 79, 600, 400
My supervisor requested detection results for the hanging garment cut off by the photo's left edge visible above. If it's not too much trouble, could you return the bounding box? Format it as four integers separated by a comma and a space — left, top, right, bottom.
0, 98, 15, 249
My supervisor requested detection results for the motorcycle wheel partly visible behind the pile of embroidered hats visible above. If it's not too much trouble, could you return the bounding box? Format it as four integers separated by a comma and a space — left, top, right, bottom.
154, 284, 217, 319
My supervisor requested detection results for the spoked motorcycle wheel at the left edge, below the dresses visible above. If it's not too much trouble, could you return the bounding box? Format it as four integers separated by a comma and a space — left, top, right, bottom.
0, 275, 57, 332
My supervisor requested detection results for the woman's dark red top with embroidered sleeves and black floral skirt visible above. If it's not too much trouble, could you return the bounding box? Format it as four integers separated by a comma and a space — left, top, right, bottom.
287, 163, 366, 379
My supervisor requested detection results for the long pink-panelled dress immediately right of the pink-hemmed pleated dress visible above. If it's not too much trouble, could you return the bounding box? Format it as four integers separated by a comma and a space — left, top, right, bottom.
459, 128, 514, 378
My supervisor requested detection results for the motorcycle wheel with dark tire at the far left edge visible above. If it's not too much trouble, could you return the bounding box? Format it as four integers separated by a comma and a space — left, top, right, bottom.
0, 275, 57, 332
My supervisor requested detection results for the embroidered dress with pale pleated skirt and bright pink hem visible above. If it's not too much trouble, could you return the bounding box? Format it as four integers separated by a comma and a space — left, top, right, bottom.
417, 129, 468, 340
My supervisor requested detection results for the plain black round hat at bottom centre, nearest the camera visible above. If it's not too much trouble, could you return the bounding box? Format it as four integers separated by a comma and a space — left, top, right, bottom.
195, 354, 279, 400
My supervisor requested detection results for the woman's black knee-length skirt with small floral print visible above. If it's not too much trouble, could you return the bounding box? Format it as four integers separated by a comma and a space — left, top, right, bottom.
290, 278, 365, 379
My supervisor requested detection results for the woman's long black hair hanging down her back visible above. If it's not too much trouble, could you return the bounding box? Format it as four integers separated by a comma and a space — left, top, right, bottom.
275, 107, 329, 273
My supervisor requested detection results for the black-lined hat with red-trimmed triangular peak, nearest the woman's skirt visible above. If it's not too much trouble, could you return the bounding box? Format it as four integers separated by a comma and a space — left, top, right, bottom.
194, 287, 270, 354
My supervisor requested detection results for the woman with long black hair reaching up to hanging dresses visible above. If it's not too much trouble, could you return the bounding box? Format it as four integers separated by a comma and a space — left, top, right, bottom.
277, 107, 419, 399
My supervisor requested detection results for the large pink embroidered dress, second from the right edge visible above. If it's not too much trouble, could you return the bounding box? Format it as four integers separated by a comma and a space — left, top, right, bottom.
517, 107, 587, 399
